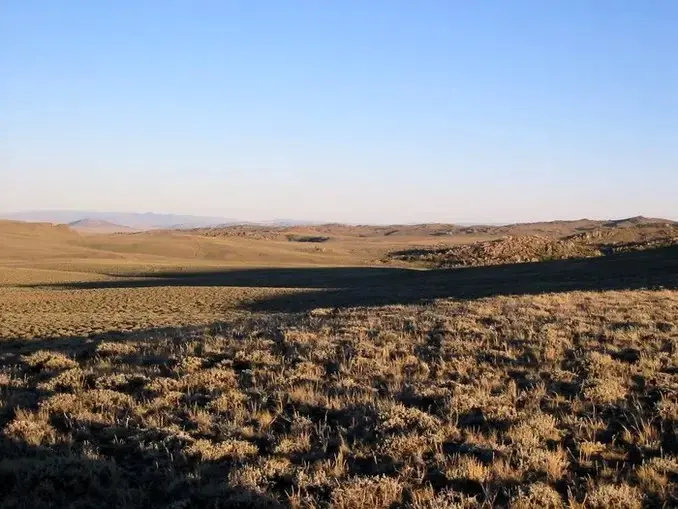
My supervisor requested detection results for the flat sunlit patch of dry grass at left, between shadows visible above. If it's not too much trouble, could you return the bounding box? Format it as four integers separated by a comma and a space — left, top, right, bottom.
0, 286, 302, 339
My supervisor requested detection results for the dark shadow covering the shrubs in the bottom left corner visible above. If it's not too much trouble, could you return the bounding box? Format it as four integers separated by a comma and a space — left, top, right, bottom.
0, 436, 286, 509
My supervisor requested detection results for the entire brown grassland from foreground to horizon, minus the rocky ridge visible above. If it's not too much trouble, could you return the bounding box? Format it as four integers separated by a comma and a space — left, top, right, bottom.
0, 221, 678, 509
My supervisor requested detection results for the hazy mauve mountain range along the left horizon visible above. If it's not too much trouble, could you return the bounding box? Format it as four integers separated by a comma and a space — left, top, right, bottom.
0, 210, 320, 231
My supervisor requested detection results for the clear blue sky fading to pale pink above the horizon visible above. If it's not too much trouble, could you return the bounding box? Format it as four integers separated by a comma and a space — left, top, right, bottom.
0, 0, 678, 222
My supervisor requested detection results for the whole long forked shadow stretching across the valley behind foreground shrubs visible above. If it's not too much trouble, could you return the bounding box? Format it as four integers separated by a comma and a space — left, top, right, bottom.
35, 246, 678, 312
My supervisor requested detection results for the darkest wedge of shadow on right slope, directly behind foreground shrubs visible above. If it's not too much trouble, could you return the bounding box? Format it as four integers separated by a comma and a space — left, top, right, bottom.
254, 246, 678, 312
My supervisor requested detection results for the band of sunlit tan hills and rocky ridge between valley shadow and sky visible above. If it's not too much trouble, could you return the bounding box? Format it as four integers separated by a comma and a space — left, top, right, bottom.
0, 213, 678, 270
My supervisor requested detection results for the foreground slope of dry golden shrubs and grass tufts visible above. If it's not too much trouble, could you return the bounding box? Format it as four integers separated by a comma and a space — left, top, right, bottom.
0, 289, 678, 508
